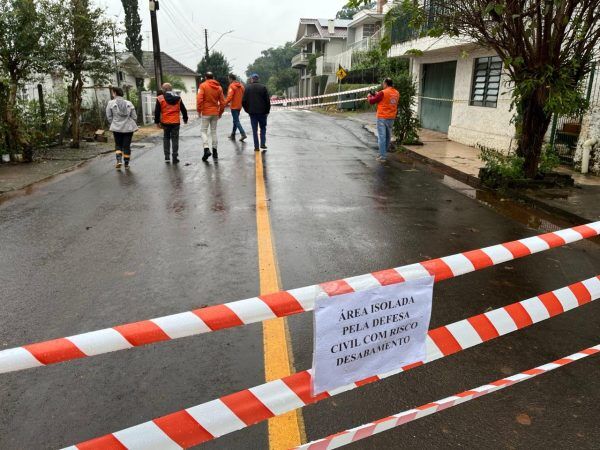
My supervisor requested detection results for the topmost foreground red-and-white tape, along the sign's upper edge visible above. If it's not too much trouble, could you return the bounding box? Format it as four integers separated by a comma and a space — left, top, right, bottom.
0, 222, 600, 373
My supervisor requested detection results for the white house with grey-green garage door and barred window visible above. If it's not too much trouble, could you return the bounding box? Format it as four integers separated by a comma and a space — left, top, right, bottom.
389, 0, 516, 151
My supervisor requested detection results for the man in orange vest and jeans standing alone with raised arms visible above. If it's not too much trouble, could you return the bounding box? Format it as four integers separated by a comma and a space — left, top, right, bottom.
368, 78, 400, 162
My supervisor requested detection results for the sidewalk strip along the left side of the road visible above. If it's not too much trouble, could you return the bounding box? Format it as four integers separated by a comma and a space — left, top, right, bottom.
0, 128, 160, 195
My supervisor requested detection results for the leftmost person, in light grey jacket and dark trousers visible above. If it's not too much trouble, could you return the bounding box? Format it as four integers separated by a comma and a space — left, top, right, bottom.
106, 87, 138, 169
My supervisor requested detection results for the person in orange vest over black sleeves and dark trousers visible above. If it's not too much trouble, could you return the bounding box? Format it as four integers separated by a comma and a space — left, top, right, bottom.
154, 83, 188, 164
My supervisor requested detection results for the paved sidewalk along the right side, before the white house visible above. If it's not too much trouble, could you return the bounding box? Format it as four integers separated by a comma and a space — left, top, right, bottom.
351, 113, 600, 222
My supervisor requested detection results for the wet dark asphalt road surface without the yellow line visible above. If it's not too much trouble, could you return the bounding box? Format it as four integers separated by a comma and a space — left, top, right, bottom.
0, 112, 600, 450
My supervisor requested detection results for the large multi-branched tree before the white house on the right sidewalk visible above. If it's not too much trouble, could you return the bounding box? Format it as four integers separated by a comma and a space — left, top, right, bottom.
351, 0, 600, 178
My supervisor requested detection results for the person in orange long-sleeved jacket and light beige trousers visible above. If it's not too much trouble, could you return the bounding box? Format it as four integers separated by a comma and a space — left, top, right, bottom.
196, 72, 225, 162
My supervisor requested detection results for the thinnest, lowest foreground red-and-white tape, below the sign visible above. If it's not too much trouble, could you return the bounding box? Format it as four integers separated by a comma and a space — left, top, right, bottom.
294, 345, 600, 450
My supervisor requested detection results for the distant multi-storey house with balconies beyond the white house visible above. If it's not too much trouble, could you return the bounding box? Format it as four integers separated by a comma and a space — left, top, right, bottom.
292, 19, 350, 97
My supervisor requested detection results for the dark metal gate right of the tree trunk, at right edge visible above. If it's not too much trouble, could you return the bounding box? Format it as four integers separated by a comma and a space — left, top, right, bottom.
550, 61, 600, 166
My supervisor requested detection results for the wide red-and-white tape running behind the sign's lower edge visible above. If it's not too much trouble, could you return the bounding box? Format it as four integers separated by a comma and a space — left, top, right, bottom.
64, 275, 600, 450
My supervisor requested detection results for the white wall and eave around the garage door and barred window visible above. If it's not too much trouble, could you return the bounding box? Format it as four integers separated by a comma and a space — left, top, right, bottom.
412, 47, 515, 151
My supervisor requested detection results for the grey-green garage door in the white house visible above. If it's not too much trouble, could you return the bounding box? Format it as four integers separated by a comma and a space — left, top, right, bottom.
421, 61, 456, 133
